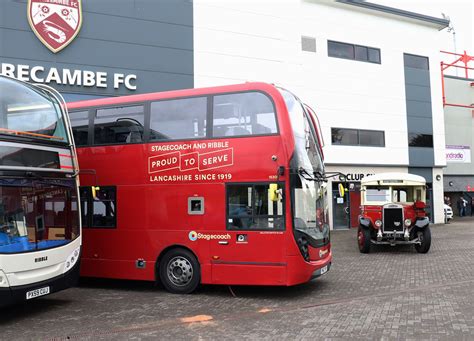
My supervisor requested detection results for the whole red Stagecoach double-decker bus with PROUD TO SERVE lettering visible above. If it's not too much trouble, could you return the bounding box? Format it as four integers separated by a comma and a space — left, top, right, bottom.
68, 83, 332, 293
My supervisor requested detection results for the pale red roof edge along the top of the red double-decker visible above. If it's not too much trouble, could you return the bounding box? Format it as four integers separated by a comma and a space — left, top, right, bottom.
67, 82, 276, 110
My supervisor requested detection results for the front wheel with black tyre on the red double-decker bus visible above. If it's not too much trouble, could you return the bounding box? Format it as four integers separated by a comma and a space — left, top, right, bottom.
159, 248, 201, 294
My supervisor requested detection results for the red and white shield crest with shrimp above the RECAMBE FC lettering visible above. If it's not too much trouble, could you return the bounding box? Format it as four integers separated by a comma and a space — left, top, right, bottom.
28, 0, 82, 53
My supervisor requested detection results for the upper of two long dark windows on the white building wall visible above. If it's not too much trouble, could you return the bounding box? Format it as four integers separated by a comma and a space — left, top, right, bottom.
328, 40, 381, 64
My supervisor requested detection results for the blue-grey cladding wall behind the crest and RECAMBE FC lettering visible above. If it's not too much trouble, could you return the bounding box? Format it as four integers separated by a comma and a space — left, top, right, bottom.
0, 0, 194, 95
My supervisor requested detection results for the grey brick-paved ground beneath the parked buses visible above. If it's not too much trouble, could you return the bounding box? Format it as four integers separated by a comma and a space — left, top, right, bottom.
0, 217, 474, 340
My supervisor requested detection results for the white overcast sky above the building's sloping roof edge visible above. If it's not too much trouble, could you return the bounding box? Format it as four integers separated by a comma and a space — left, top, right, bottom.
376, 0, 474, 56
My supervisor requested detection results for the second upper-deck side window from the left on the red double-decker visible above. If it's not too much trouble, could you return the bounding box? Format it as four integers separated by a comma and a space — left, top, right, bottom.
94, 105, 145, 145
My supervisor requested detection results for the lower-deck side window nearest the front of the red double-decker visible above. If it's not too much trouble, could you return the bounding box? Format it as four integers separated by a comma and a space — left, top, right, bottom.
227, 183, 285, 230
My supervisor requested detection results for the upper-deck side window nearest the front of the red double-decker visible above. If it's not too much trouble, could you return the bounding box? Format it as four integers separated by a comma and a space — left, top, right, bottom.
212, 92, 278, 137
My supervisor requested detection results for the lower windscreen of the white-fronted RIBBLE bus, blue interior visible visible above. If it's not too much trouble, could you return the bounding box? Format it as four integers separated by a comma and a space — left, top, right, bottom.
0, 178, 80, 254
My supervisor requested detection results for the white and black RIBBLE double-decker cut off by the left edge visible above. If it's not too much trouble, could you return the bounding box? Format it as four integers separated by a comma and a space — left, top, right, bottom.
0, 76, 81, 306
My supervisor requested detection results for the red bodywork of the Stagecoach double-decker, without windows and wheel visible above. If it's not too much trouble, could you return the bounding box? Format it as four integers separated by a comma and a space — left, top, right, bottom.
68, 83, 332, 286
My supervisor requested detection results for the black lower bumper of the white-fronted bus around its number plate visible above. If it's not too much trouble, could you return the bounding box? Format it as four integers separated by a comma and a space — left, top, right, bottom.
0, 261, 80, 307
